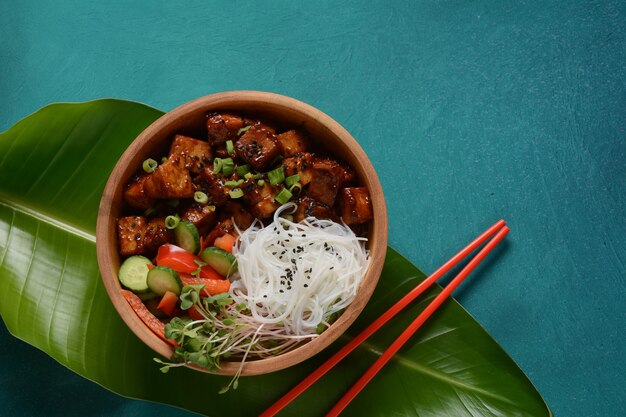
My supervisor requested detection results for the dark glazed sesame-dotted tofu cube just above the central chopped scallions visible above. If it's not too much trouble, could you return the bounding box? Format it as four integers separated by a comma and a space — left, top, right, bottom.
235, 124, 280, 171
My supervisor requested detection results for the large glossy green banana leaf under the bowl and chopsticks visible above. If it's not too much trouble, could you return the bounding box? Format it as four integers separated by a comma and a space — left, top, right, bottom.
0, 99, 551, 417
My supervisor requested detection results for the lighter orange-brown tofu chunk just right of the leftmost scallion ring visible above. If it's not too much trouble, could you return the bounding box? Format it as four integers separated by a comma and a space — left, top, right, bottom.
144, 158, 194, 199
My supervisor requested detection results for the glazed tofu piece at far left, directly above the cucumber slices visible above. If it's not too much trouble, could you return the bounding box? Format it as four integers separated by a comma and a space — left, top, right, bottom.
117, 216, 172, 257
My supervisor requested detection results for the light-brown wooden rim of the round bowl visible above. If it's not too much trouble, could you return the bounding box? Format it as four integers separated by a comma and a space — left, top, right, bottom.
96, 90, 388, 375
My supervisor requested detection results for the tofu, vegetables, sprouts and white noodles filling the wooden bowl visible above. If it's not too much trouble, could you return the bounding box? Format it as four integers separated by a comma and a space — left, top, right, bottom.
117, 112, 373, 385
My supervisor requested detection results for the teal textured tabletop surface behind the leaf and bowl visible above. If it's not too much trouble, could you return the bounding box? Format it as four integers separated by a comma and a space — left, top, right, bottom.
0, 0, 626, 416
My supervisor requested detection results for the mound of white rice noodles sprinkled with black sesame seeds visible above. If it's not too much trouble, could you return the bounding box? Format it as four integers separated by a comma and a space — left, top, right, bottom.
230, 203, 370, 335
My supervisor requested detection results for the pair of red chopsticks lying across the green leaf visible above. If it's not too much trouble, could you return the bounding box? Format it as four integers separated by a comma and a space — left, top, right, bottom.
260, 220, 509, 417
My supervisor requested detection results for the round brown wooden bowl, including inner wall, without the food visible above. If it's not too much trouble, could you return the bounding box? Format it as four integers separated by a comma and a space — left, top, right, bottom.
96, 91, 387, 375
